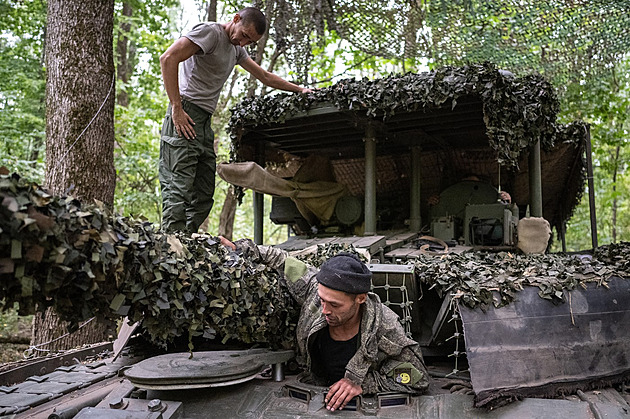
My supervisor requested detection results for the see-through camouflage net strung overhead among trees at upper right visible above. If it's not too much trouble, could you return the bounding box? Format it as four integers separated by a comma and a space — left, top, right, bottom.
271, 0, 630, 82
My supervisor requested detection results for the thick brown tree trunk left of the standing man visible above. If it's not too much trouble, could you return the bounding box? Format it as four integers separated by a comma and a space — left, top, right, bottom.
32, 0, 116, 350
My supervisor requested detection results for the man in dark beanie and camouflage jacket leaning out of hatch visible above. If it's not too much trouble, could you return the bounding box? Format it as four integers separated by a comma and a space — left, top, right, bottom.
221, 238, 429, 411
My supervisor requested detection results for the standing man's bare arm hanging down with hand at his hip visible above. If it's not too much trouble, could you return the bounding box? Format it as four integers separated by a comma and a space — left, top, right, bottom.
160, 37, 199, 140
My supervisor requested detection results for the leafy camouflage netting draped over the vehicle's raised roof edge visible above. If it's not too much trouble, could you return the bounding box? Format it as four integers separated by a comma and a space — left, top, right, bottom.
228, 63, 586, 167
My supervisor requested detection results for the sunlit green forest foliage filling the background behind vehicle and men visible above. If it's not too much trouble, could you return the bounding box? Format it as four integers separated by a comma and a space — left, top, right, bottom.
0, 0, 630, 248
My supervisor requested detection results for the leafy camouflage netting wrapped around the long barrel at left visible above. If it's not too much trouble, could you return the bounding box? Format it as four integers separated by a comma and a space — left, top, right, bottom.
0, 175, 297, 348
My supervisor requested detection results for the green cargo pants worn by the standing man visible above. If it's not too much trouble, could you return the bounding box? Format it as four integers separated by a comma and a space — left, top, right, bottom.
159, 100, 216, 233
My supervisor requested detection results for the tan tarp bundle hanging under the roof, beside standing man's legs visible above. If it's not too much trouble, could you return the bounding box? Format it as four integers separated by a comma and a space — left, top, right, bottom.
217, 162, 346, 225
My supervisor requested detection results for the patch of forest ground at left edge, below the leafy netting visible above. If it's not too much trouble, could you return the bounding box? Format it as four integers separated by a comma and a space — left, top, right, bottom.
0, 310, 33, 366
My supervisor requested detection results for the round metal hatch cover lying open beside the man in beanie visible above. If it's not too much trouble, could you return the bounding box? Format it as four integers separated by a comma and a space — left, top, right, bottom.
125, 348, 295, 390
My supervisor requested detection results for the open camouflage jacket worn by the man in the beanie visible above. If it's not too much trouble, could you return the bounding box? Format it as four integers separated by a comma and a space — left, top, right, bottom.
236, 240, 429, 394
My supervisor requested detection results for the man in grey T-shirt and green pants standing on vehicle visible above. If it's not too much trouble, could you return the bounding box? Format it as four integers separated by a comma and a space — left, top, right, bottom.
159, 7, 310, 233
